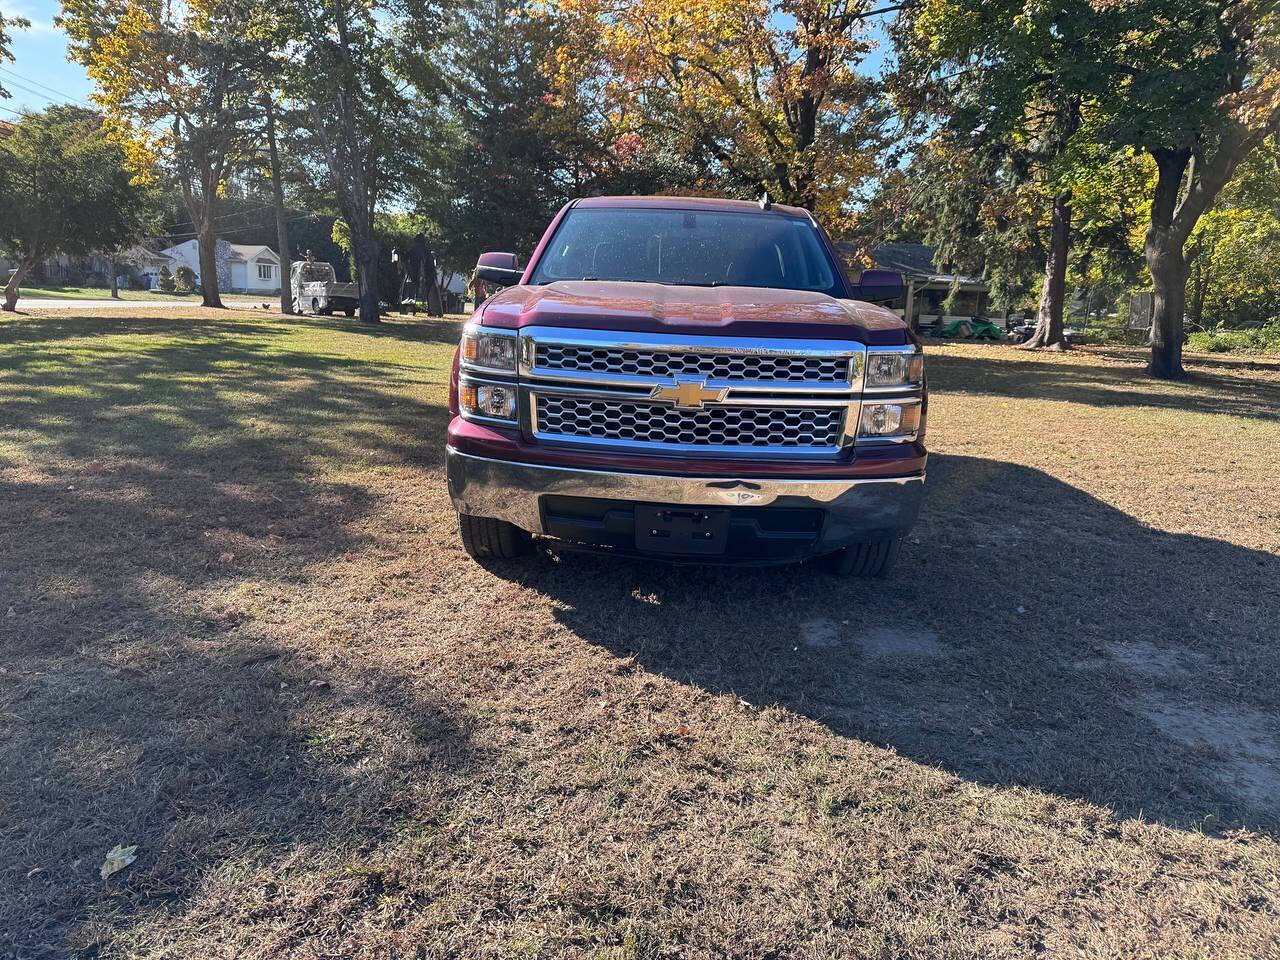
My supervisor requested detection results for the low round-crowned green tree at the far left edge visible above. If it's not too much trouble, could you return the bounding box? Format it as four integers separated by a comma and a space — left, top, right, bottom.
0, 106, 146, 311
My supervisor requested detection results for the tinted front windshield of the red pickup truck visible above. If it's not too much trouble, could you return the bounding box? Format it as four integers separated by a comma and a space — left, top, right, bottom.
530, 207, 844, 296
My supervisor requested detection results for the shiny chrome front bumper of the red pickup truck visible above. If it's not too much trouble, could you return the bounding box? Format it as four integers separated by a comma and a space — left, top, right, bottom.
445, 447, 924, 549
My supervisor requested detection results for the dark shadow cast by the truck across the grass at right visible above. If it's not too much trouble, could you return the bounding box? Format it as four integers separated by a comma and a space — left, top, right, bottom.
518, 456, 1280, 831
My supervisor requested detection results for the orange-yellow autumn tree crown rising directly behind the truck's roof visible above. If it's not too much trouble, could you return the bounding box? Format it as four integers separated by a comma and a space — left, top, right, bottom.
552, 0, 886, 230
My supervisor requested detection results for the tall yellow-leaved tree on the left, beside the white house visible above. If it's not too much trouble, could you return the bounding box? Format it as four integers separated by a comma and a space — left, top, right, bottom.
58, 0, 255, 307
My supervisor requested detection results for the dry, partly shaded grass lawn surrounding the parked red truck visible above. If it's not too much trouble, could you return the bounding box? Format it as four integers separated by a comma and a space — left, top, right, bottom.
0, 307, 1280, 960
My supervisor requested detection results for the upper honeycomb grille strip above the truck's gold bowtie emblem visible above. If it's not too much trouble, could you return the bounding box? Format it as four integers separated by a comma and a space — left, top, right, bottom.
535, 343, 849, 384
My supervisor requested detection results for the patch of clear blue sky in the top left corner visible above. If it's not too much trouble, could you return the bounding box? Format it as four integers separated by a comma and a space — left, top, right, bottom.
0, 0, 93, 120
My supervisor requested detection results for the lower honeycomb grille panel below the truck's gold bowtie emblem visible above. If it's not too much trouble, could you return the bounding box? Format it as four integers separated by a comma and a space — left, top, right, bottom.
538, 396, 845, 449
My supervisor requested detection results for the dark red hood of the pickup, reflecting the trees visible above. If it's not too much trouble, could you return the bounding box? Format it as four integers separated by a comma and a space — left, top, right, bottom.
476, 280, 909, 346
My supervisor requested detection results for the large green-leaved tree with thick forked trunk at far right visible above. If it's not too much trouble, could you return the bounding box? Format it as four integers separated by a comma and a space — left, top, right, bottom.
900, 0, 1280, 378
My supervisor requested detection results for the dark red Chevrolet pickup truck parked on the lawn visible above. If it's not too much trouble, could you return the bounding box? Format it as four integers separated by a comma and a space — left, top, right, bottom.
447, 197, 928, 576
